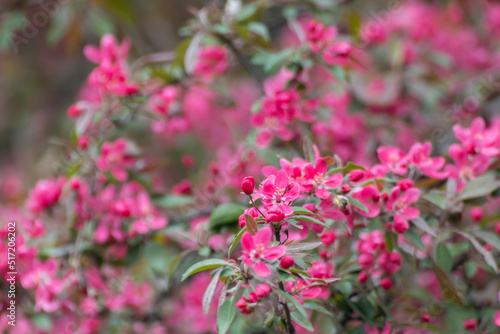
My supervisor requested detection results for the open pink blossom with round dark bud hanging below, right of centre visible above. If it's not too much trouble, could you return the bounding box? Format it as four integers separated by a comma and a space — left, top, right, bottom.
386, 186, 420, 233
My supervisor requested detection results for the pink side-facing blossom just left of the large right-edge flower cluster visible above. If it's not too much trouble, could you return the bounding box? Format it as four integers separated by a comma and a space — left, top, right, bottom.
407, 142, 448, 179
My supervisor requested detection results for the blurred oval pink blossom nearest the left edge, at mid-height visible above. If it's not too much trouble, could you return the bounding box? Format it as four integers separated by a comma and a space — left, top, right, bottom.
26, 178, 65, 213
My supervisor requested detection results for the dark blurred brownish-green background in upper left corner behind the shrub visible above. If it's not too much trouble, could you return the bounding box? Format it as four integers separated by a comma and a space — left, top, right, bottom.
0, 0, 204, 185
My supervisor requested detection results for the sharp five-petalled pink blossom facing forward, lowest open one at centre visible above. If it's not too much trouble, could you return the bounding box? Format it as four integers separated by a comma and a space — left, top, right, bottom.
241, 227, 286, 277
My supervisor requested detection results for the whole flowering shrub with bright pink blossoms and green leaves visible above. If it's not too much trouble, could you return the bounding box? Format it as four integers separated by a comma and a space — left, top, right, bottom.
0, 1, 500, 334
